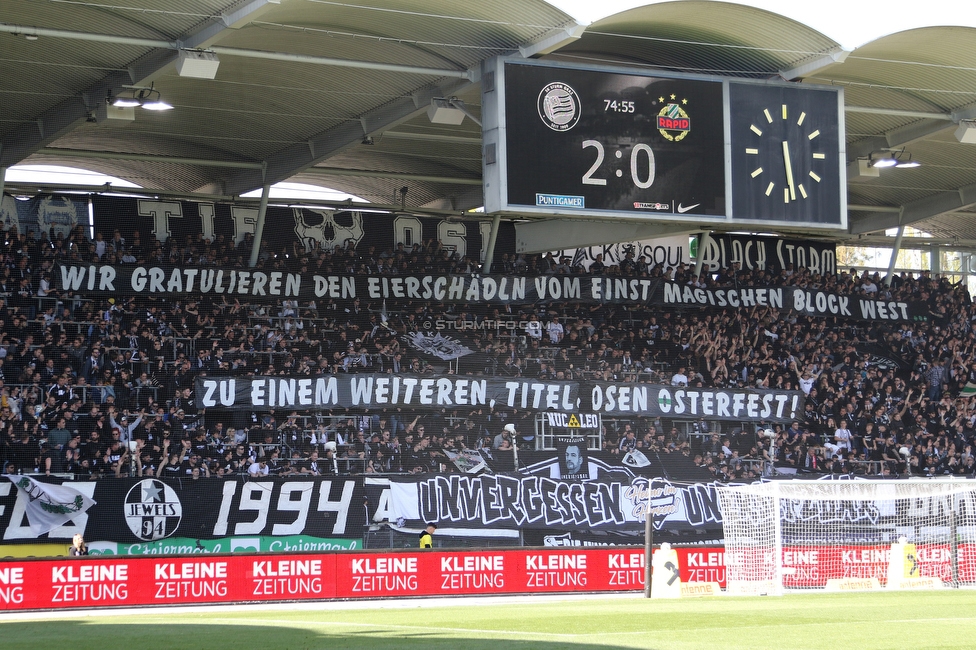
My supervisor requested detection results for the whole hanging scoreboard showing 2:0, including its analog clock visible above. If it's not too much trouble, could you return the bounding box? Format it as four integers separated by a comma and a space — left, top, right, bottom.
482, 57, 847, 229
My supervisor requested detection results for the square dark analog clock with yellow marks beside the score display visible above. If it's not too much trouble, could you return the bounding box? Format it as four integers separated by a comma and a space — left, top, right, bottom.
730, 84, 841, 225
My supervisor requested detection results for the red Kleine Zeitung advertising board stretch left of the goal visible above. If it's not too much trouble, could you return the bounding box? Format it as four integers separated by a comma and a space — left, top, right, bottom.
0, 548, 644, 610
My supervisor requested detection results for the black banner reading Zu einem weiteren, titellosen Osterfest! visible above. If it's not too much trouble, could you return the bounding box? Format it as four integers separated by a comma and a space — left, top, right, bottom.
195, 373, 803, 421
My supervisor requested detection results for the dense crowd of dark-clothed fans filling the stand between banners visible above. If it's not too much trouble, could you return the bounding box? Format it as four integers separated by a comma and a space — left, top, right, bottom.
0, 223, 976, 480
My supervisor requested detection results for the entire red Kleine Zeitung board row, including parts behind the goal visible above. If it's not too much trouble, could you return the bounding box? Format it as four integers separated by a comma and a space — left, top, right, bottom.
0, 544, 976, 610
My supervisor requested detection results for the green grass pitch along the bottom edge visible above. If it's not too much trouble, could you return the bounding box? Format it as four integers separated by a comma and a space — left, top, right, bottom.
0, 589, 976, 650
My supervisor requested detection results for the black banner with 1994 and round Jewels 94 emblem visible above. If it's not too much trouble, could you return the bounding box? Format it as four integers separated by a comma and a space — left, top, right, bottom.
0, 477, 366, 544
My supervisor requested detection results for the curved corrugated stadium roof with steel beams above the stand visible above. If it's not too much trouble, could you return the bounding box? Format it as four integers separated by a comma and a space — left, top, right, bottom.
0, 0, 976, 247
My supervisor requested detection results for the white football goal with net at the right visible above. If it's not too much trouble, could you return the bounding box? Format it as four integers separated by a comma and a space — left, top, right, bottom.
718, 480, 976, 595
